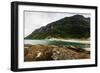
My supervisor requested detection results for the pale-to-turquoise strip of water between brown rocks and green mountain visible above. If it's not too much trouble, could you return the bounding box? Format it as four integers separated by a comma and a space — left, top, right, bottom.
24, 40, 89, 48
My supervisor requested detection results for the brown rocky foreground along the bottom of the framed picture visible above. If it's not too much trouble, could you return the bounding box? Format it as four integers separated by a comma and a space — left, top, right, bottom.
24, 44, 90, 61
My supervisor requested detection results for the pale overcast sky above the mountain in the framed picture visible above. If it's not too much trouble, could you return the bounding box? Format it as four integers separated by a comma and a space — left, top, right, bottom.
24, 11, 90, 37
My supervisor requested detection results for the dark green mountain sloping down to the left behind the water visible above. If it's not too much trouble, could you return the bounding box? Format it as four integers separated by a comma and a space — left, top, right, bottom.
25, 15, 90, 39
